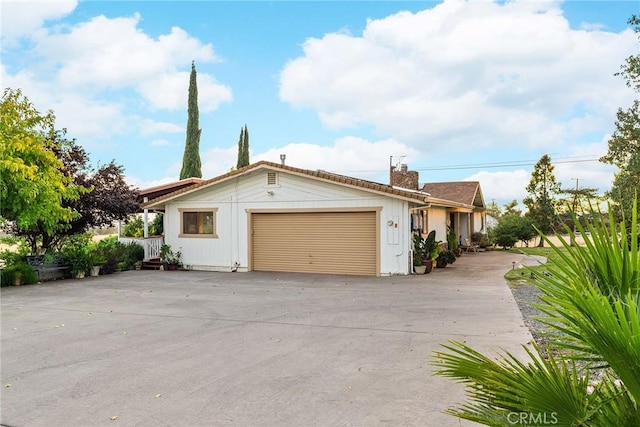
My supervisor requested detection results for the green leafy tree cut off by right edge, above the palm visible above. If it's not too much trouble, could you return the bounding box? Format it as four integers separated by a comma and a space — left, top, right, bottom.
600, 15, 640, 224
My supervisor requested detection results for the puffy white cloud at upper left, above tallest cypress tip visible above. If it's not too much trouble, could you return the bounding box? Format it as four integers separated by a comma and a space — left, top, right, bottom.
34, 14, 218, 90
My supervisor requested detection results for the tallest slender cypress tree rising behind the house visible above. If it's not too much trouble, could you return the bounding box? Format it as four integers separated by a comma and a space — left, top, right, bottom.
180, 61, 202, 179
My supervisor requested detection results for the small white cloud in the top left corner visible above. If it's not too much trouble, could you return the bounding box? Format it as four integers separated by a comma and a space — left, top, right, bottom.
1, 0, 78, 46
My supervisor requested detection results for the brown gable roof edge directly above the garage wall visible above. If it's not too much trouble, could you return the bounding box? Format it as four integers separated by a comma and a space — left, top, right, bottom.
143, 160, 429, 208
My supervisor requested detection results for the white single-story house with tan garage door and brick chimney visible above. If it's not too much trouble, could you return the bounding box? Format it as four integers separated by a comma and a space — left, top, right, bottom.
136, 161, 484, 276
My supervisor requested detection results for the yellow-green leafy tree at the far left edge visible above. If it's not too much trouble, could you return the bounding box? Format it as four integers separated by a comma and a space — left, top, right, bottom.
0, 88, 84, 237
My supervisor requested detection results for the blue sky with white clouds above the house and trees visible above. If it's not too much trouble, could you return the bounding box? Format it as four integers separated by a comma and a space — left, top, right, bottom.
0, 0, 640, 207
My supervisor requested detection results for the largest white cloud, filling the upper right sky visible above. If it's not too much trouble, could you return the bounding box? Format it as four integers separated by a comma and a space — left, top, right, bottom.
280, 0, 637, 150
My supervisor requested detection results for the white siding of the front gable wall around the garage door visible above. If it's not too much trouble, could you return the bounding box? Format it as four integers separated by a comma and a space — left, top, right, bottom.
165, 170, 416, 275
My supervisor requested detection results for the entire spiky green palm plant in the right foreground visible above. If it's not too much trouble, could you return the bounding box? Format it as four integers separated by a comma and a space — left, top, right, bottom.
432, 201, 640, 427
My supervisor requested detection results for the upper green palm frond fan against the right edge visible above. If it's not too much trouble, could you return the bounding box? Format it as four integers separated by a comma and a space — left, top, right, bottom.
536, 200, 640, 401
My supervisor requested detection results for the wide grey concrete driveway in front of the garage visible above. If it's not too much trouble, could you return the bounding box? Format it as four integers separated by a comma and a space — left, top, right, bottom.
0, 252, 531, 427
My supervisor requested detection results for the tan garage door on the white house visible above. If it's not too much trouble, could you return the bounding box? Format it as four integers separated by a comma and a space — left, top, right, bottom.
252, 212, 377, 276
